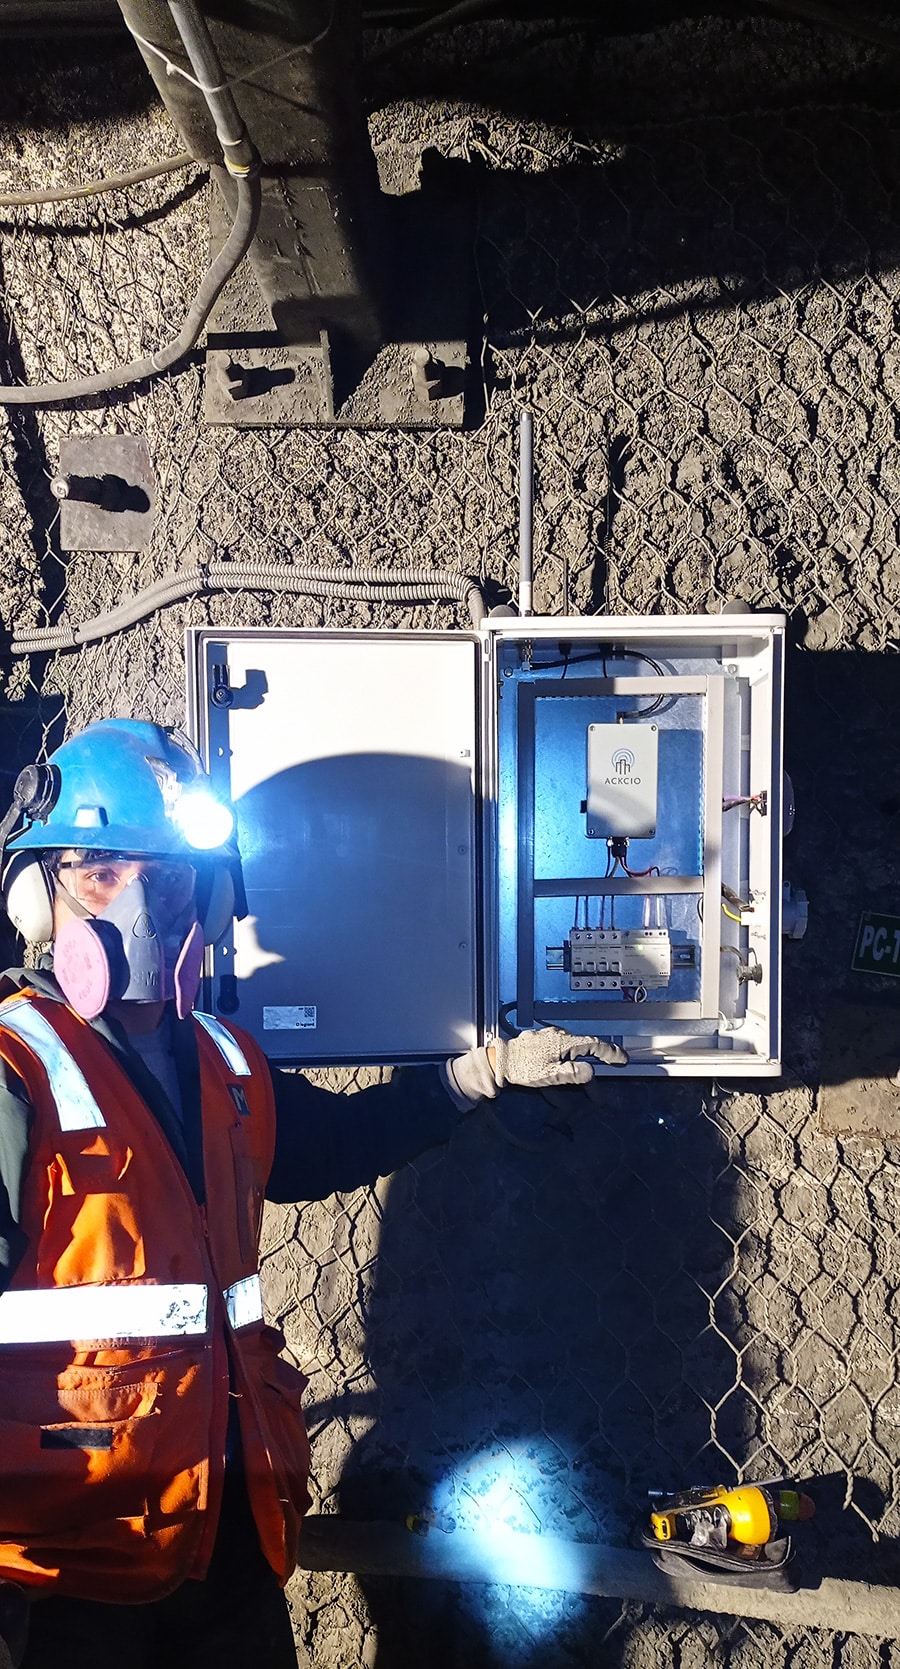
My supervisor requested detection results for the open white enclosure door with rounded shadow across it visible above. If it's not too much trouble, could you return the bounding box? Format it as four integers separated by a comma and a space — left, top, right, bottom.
192, 631, 479, 1063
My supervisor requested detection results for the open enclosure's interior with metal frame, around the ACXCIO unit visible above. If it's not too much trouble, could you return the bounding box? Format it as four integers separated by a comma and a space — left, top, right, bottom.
486, 618, 781, 1075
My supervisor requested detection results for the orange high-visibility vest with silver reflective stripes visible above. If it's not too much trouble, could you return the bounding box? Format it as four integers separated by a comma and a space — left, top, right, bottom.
0, 991, 309, 1602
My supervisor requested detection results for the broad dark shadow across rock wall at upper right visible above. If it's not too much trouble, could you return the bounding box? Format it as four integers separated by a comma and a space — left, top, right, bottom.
479, 95, 900, 352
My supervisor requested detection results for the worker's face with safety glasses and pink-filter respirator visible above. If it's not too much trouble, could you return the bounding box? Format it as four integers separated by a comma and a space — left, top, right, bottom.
53, 860, 204, 1020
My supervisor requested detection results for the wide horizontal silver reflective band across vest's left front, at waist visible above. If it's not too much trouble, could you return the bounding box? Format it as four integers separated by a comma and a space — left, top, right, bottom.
0, 1283, 209, 1345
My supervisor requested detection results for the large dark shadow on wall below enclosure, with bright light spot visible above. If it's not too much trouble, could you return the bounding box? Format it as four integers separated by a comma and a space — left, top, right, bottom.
330, 1082, 748, 1669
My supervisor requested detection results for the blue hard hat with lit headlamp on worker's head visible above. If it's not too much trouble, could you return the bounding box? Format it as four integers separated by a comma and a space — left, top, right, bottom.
8, 719, 234, 858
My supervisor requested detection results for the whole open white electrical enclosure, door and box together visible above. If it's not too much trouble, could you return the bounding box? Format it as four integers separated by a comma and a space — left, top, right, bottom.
187, 614, 785, 1078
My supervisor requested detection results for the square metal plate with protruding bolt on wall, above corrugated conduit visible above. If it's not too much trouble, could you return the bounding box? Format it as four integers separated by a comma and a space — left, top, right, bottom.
50, 434, 157, 551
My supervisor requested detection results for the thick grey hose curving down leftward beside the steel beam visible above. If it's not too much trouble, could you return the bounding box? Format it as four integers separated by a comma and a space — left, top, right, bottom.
0, 169, 262, 406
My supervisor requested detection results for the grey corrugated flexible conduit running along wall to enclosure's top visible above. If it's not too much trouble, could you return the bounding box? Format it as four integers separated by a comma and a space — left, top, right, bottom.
10, 562, 484, 654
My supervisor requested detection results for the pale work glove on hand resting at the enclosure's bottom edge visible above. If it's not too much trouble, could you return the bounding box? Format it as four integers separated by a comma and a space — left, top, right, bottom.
446, 1026, 628, 1102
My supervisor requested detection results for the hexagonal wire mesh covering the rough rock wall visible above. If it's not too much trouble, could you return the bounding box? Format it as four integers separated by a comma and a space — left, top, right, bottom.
0, 23, 900, 1669
